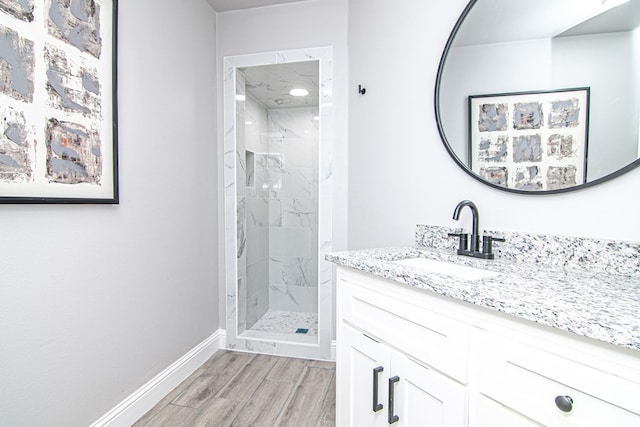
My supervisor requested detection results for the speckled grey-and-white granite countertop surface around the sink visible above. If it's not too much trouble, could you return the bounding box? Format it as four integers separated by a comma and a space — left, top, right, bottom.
326, 247, 640, 351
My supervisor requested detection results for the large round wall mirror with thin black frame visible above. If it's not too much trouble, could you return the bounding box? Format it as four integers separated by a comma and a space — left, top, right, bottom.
435, 0, 640, 194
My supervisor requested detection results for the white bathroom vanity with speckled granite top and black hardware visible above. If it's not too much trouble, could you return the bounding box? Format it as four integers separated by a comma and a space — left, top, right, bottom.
327, 227, 640, 427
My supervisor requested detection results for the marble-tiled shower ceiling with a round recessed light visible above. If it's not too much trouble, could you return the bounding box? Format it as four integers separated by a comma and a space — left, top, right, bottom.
238, 61, 320, 109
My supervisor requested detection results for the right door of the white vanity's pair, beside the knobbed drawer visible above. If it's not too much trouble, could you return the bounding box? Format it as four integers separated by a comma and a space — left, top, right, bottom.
389, 352, 468, 427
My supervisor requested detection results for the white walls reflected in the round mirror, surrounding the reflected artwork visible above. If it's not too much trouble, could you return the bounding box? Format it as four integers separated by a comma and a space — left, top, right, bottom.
440, 32, 638, 181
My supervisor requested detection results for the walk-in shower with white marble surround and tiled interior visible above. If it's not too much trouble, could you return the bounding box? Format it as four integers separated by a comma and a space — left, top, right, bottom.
224, 48, 332, 359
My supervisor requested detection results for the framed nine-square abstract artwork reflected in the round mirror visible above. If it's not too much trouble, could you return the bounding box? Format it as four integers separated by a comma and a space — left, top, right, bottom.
469, 88, 589, 190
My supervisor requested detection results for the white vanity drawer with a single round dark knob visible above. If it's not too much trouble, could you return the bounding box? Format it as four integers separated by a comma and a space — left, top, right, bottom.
478, 332, 640, 426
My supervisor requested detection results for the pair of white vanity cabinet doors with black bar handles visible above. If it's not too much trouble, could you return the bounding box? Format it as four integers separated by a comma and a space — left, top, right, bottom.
338, 324, 467, 427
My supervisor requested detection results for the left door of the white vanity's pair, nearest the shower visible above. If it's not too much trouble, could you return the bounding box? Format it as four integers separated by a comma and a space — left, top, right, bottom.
338, 324, 391, 427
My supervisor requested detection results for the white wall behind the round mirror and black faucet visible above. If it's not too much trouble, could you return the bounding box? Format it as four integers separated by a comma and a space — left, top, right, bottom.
349, 0, 640, 249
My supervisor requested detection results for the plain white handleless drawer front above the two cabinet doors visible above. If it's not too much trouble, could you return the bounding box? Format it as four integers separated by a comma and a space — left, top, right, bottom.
339, 274, 470, 384
